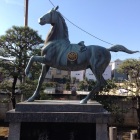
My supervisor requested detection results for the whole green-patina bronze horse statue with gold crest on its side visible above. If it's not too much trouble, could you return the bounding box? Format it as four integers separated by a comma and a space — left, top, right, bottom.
25, 6, 137, 104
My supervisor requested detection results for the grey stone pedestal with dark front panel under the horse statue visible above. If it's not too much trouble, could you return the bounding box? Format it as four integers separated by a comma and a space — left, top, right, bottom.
6, 100, 110, 140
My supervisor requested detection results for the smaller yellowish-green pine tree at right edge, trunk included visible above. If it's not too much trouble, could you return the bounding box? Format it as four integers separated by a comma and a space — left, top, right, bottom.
118, 59, 140, 139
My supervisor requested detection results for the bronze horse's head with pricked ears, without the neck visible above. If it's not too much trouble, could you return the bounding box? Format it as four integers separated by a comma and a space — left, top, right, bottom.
38, 6, 59, 25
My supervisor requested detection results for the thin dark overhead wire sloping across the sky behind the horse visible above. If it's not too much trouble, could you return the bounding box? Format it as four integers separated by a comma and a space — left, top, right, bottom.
49, 0, 113, 45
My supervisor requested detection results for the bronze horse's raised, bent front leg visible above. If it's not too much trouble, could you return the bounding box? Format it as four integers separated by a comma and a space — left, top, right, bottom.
25, 56, 45, 78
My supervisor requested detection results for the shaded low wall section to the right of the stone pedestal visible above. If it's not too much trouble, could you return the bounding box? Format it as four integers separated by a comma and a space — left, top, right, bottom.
92, 95, 138, 127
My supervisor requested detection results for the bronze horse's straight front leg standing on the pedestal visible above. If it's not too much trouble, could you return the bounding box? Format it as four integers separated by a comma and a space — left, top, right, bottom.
27, 64, 50, 102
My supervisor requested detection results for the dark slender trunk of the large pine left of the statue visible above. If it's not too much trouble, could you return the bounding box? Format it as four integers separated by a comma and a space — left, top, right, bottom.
11, 76, 18, 109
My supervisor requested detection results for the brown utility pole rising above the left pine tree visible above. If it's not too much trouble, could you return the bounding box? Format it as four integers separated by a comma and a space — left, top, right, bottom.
24, 0, 29, 26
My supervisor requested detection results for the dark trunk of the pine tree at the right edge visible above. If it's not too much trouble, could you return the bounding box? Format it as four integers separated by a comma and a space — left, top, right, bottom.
136, 96, 140, 139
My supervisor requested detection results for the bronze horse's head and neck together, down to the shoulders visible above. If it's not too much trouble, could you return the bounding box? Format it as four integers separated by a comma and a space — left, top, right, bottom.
39, 6, 68, 43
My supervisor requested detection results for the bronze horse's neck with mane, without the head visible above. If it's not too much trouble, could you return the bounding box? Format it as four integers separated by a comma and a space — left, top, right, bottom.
45, 11, 69, 44
